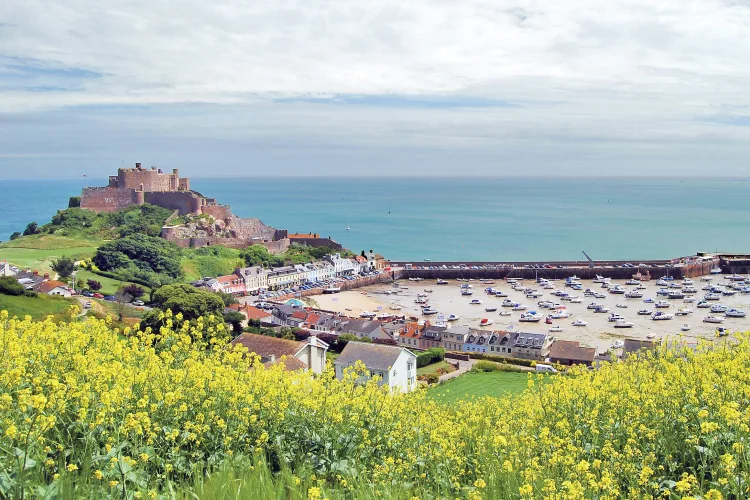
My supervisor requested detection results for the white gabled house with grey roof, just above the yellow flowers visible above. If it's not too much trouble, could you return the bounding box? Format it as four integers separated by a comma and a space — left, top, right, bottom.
335, 342, 417, 393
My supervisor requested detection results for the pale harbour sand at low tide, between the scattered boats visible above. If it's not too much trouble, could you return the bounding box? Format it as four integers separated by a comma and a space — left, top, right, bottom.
312, 277, 750, 352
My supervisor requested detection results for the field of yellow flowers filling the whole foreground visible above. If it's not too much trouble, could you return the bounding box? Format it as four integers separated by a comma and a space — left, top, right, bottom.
0, 312, 750, 499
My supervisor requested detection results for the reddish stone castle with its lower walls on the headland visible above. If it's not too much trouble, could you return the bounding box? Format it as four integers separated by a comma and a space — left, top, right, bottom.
80, 163, 341, 253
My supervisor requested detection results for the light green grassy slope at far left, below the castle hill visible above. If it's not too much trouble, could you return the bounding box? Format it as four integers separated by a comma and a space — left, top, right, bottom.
0, 235, 101, 272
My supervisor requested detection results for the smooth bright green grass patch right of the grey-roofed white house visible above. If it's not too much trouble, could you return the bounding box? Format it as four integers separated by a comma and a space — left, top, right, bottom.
428, 372, 528, 403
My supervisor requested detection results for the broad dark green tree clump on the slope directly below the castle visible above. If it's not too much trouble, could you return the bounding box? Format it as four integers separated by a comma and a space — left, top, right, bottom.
92, 234, 180, 280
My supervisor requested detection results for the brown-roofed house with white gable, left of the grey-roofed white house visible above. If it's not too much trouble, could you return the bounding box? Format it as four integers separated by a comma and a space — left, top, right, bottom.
232, 333, 328, 373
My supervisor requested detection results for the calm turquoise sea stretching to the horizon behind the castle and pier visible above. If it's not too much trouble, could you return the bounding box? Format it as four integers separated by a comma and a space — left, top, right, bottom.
0, 177, 750, 262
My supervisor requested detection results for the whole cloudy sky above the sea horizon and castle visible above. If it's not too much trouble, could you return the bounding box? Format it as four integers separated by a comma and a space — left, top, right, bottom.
0, 0, 750, 178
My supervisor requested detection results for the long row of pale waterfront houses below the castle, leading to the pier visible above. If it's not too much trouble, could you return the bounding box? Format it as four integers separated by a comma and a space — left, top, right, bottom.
205, 251, 387, 295
